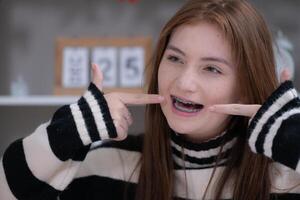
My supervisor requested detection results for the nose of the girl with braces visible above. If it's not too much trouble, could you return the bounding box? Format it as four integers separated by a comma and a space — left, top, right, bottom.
176, 68, 198, 92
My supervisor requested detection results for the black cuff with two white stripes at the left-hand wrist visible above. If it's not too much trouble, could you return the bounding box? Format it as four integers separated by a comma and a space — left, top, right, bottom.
47, 83, 117, 161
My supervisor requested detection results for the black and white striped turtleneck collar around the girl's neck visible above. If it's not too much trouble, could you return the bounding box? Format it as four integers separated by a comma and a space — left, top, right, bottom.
171, 131, 237, 169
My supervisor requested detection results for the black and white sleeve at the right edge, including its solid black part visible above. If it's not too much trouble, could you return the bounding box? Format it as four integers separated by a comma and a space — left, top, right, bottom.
248, 81, 300, 172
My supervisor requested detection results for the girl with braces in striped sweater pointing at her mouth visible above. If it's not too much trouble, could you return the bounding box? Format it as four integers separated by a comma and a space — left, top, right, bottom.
0, 0, 300, 200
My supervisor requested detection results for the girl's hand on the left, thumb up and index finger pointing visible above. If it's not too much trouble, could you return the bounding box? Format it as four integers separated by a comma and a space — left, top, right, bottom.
92, 64, 164, 141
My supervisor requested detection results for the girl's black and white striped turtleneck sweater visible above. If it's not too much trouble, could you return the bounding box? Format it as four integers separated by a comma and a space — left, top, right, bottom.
0, 81, 300, 200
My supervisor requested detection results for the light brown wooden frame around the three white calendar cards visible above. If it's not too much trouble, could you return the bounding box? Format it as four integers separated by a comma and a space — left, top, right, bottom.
54, 37, 152, 95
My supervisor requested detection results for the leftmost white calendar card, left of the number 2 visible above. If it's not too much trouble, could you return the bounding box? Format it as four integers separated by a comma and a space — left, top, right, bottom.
62, 47, 90, 88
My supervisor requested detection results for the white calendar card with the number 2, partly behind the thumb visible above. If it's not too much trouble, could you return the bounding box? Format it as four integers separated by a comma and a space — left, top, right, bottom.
92, 47, 118, 87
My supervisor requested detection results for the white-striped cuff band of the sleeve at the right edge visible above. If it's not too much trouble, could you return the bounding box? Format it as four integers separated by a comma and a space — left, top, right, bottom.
248, 81, 300, 158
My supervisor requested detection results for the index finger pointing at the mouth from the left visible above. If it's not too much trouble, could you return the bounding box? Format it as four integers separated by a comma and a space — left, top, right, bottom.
119, 93, 164, 105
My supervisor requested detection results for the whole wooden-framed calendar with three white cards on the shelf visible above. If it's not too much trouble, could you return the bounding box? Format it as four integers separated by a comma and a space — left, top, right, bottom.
54, 37, 151, 95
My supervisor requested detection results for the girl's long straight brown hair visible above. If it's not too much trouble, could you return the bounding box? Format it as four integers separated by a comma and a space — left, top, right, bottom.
136, 0, 278, 200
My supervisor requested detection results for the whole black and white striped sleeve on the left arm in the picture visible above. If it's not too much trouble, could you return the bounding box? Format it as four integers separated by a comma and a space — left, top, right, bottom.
0, 83, 117, 200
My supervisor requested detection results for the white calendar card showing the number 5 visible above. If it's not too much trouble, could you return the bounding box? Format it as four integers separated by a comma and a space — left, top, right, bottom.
120, 47, 145, 87
